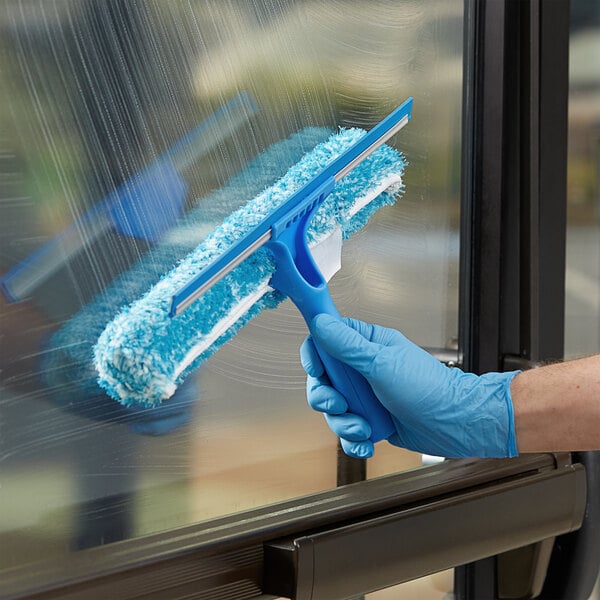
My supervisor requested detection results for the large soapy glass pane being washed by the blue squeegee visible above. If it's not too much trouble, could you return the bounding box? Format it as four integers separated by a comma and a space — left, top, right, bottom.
0, 0, 463, 580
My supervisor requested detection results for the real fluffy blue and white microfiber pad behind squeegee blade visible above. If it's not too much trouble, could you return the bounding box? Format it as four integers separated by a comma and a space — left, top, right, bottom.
94, 129, 405, 406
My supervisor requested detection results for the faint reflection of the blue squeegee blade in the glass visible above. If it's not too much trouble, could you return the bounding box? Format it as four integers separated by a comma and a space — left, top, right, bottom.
0, 93, 256, 302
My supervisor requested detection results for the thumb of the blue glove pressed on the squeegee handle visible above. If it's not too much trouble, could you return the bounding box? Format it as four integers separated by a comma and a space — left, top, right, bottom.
310, 314, 381, 377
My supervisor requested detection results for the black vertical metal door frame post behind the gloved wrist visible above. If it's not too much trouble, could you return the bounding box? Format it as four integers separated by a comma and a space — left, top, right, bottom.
455, 0, 600, 600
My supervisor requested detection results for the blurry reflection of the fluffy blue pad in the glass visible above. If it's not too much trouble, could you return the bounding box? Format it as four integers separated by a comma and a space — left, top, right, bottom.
40, 127, 332, 398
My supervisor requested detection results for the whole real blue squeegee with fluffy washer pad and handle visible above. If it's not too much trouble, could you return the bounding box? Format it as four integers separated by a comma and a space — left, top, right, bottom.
95, 98, 412, 441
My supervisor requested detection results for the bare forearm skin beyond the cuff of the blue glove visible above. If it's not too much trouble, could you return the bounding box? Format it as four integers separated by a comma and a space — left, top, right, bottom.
510, 354, 600, 452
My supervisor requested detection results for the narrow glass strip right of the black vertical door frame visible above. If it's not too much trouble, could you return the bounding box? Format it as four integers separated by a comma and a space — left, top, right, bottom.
565, 0, 600, 358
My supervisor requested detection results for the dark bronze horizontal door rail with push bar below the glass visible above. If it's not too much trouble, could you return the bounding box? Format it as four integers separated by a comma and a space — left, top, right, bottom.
2, 454, 586, 600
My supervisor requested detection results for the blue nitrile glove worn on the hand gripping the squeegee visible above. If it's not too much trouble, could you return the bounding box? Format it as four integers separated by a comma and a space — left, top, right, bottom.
300, 315, 518, 458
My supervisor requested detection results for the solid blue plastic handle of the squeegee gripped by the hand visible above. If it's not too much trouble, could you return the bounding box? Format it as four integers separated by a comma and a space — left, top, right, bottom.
267, 178, 395, 442
